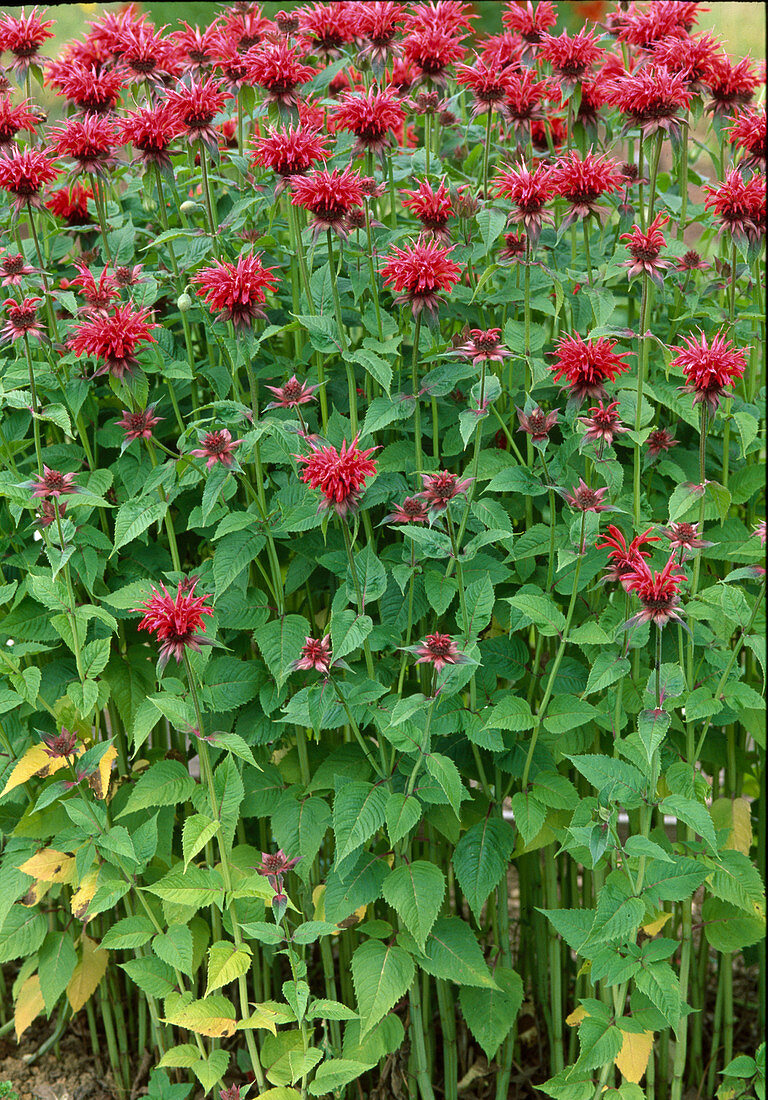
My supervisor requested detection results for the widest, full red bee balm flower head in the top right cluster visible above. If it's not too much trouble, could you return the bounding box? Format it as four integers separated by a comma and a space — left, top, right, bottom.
606, 65, 693, 138
